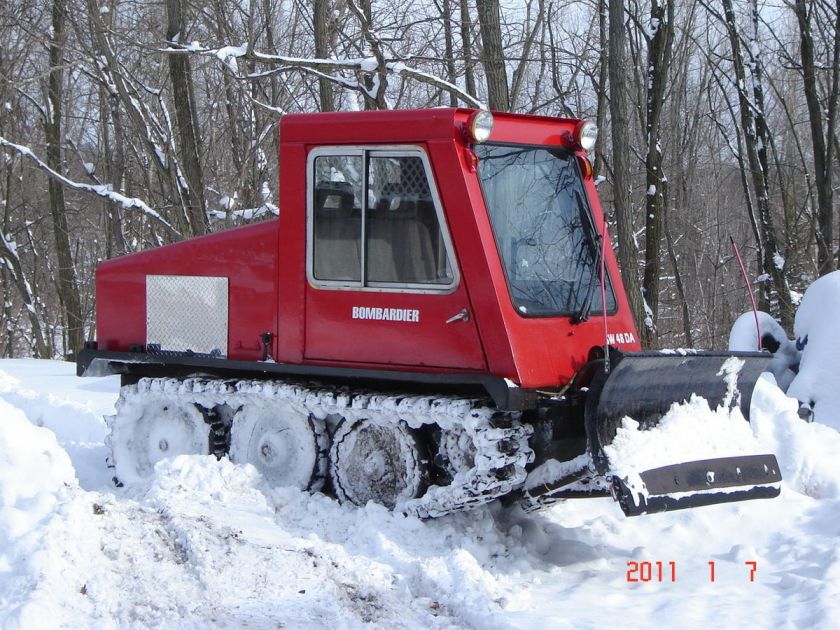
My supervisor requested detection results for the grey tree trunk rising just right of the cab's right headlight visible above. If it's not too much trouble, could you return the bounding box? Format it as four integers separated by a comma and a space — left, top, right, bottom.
609, 0, 645, 336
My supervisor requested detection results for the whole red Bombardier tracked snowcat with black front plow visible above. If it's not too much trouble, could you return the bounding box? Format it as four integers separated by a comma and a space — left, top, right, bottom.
77, 108, 781, 517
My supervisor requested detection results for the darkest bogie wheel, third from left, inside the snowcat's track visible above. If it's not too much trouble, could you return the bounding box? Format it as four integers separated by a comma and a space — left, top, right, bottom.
330, 419, 427, 509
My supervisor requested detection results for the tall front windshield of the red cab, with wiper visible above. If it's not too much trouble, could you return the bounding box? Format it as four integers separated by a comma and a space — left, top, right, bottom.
474, 144, 616, 319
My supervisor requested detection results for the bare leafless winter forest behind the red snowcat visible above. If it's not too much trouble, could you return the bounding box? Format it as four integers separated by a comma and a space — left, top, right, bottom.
0, 0, 840, 357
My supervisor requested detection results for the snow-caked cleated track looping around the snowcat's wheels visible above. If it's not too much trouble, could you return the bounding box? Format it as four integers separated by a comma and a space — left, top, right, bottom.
110, 378, 534, 518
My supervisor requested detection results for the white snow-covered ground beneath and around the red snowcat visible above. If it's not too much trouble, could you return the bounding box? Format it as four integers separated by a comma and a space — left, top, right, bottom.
0, 360, 840, 628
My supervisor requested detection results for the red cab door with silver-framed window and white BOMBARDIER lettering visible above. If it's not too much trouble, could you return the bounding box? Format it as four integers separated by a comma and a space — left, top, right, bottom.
304, 146, 486, 371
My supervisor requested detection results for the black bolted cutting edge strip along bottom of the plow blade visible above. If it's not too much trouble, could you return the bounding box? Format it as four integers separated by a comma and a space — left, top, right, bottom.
610, 455, 782, 516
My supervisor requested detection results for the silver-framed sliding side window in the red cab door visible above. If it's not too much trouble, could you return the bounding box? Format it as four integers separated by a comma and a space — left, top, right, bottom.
310, 150, 454, 290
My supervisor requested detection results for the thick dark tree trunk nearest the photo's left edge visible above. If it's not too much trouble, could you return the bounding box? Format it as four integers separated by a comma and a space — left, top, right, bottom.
44, 0, 84, 353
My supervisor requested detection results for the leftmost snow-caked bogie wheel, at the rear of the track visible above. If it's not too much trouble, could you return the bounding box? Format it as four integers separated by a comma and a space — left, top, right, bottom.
106, 398, 210, 485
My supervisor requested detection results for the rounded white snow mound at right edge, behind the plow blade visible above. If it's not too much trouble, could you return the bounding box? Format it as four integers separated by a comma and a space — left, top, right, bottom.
787, 271, 840, 431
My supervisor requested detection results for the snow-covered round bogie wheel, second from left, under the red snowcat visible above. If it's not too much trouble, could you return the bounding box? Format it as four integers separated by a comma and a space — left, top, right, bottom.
230, 400, 327, 490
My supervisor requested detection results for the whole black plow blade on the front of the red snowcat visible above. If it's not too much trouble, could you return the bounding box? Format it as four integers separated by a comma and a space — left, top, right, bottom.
586, 352, 781, 516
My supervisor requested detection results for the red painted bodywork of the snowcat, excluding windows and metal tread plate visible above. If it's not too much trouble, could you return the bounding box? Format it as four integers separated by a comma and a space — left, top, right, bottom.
97, 109, 639, 387
